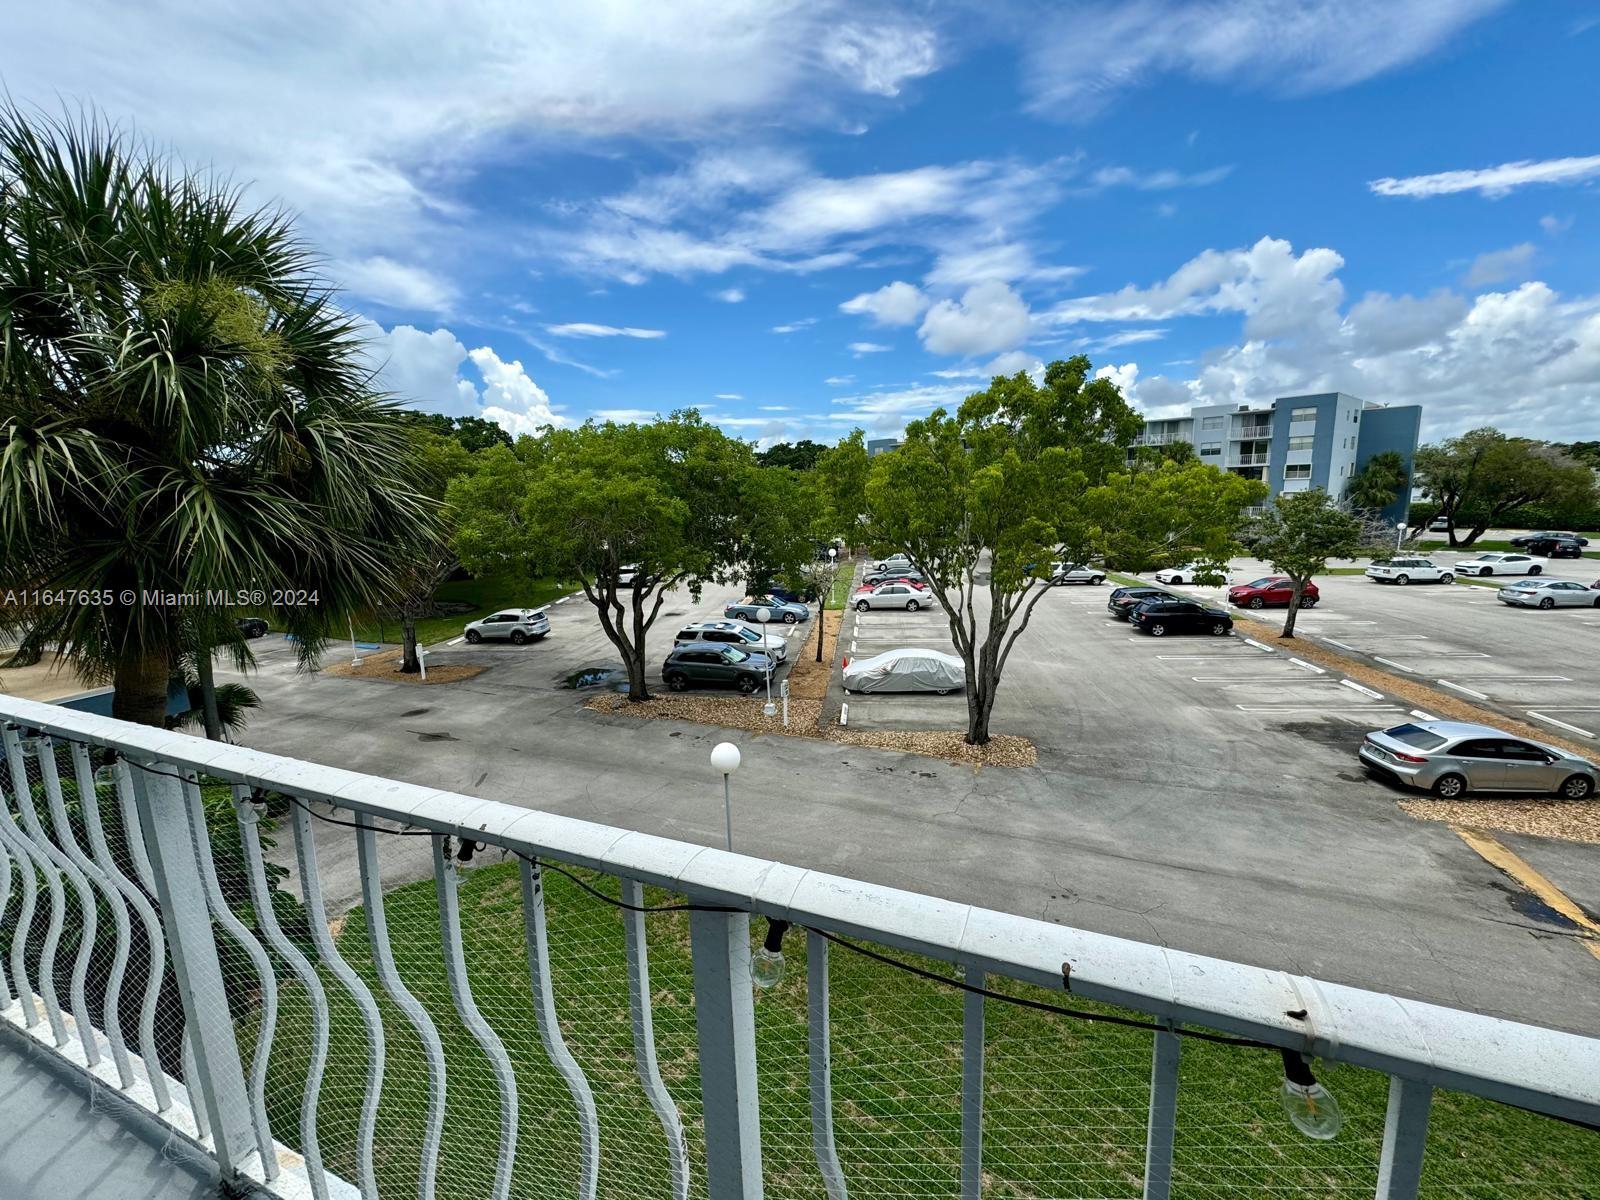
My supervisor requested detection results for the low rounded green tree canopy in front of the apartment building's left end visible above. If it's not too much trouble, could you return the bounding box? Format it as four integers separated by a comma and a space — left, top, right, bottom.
1082, 460, 1267, 573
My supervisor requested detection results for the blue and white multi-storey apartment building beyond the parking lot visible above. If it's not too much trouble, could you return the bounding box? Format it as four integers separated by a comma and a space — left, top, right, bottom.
1134, 392, 1422, 522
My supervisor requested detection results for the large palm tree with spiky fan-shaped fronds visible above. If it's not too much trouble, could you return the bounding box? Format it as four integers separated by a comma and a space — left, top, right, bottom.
0, 109, 434, 725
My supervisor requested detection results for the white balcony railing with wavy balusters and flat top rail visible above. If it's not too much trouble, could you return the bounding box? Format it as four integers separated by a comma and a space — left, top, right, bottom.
0, 698, 1600, 1200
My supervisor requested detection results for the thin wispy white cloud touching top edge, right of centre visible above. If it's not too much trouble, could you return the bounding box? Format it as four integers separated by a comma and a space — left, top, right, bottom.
1019, 0, 1506, 117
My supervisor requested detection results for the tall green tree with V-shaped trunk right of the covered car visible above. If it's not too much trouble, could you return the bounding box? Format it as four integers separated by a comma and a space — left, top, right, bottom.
866, 355, 1142, 746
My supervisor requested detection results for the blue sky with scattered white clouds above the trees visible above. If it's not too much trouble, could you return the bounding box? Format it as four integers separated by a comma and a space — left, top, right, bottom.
0, 0, 1600, 442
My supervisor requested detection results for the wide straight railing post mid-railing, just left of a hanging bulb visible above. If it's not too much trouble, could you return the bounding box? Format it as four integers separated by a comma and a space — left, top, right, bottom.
690, 910, 762, 1200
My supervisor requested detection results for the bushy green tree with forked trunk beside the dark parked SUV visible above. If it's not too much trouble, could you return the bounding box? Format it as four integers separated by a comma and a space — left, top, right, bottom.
446, 410, 758, 701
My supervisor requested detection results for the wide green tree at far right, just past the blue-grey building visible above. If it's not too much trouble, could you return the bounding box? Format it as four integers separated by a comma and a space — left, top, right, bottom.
1416, 427, 1595, 546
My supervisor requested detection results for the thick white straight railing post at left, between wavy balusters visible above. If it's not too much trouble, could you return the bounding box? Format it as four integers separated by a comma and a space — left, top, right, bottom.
133, 763, 256, 1178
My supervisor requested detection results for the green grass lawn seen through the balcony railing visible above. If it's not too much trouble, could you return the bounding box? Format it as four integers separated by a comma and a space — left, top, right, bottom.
240, 862, 1600, 1200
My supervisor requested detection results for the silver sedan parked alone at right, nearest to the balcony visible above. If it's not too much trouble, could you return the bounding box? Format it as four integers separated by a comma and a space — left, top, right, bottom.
1357, 722, 1600, 800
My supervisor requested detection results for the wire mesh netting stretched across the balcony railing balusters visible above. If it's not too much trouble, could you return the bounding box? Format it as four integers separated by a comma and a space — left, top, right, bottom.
0, 744, 1600, 1200
